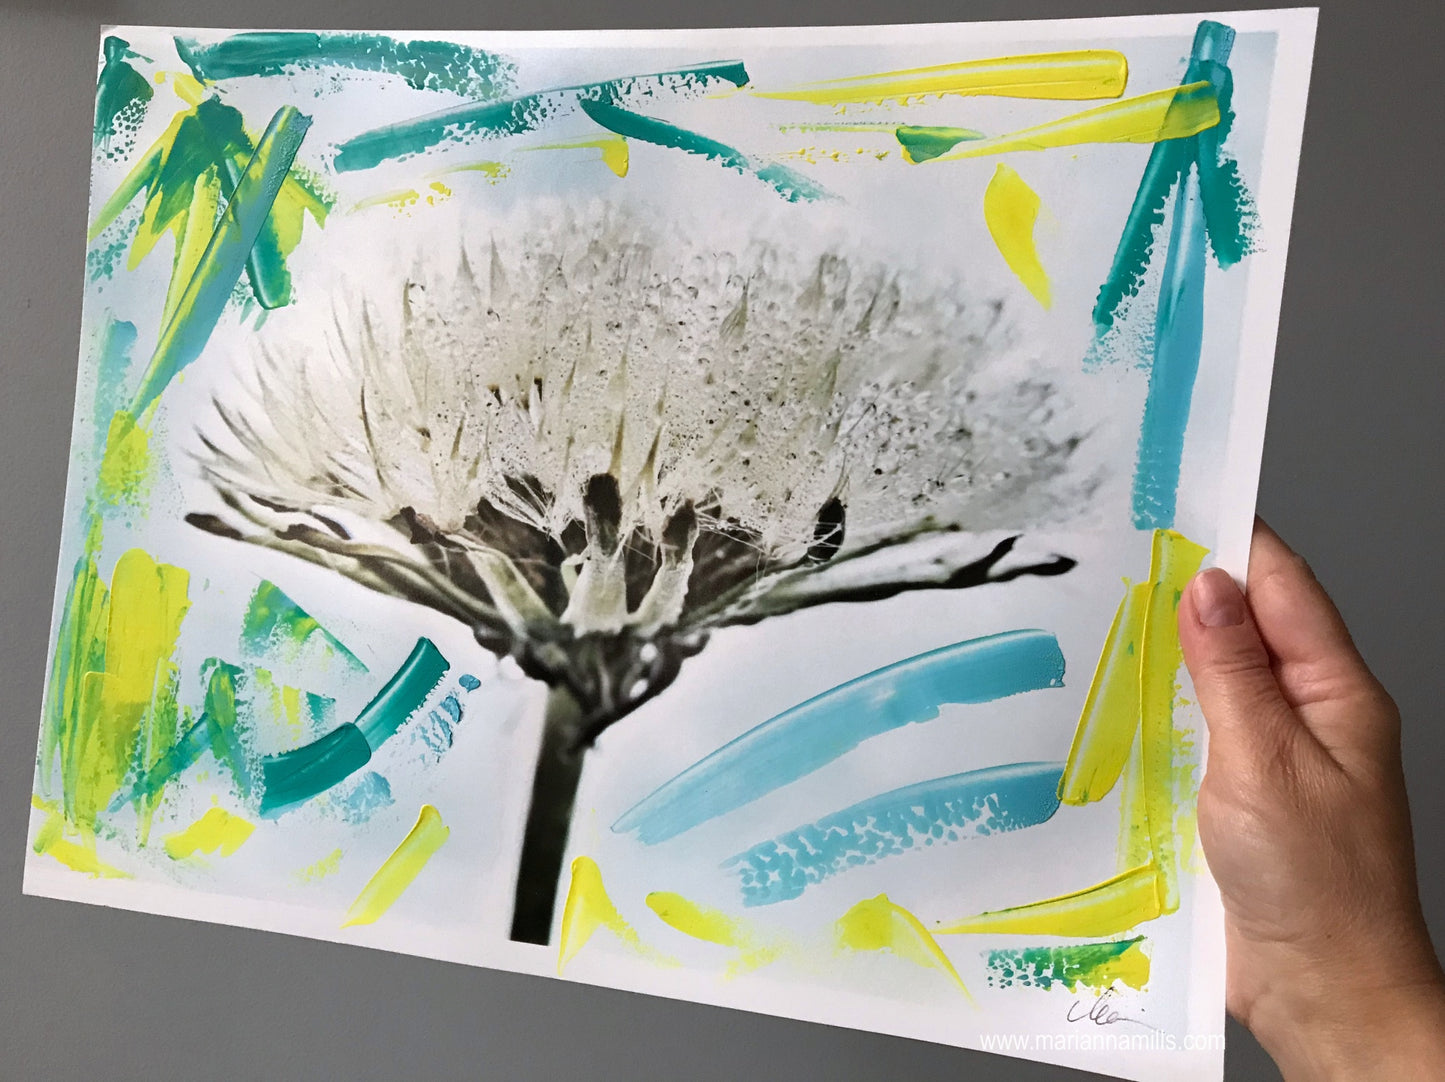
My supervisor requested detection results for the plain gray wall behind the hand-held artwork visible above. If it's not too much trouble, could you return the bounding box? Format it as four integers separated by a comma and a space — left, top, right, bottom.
0, 0, 1445, 1082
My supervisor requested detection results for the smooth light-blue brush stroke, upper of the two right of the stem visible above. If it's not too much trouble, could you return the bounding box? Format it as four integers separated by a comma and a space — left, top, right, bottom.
613, 630, 1064, 845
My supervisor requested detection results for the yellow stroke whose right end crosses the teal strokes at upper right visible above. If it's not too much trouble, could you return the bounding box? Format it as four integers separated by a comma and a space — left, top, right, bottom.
903, 82, 1220, 162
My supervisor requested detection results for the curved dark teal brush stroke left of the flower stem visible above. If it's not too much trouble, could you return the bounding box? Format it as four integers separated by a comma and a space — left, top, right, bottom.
260, 639, 448, 816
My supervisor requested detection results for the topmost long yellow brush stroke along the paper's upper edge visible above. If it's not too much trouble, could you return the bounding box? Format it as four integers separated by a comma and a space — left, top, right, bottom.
751, 49, 1129, 105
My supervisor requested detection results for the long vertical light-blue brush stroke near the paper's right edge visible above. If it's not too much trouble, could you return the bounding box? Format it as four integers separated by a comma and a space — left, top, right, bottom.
1133, 162, 1205, 530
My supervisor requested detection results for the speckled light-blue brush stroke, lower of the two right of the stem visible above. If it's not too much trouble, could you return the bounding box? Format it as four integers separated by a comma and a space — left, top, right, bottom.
723, 763, 1064, 906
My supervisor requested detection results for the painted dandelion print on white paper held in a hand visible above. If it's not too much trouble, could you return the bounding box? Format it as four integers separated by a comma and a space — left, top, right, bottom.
26, 12, 1314, 1079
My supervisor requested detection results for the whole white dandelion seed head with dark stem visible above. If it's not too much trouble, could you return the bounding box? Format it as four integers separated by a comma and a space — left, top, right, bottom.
189, 200, 1088, 942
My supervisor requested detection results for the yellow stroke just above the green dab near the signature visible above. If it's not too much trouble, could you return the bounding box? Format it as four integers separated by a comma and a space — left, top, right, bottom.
933, 864, 1165, 936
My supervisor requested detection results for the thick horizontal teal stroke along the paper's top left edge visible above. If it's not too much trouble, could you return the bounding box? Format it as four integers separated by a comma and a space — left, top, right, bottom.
175, 30, 516, 98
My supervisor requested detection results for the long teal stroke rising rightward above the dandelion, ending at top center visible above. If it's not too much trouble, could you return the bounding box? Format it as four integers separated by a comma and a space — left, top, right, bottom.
332, 61, 747, 173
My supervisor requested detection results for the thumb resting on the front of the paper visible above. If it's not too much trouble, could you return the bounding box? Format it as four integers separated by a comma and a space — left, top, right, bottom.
1179, 568, 1302, 763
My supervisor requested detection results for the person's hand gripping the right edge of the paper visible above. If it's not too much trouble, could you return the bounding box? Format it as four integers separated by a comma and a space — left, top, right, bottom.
1179, 521, 1445, 1082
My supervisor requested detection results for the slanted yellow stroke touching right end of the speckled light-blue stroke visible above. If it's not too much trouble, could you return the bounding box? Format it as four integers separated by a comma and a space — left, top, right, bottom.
1059, 582, 1153, 803
